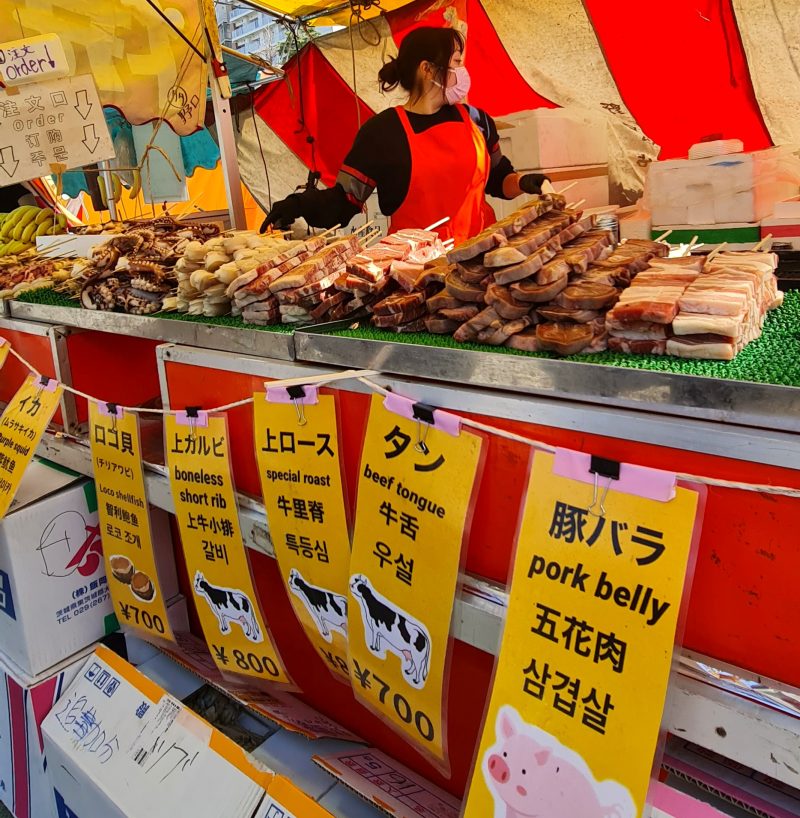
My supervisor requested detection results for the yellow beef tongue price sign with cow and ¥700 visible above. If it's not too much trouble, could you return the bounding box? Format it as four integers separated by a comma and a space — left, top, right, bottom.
348, 396, 481, 769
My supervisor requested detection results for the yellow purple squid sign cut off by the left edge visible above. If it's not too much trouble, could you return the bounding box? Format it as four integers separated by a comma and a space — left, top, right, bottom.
0, 372, 64, 520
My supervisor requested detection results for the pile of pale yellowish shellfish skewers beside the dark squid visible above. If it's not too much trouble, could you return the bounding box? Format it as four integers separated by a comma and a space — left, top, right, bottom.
175, 230, 301, 316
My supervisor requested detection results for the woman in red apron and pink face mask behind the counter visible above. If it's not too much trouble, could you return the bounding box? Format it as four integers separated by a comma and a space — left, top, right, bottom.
261, 27, 546, 243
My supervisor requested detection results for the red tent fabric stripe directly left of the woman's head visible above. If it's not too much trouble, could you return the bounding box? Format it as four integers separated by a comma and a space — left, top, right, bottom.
255, 45, 374, 187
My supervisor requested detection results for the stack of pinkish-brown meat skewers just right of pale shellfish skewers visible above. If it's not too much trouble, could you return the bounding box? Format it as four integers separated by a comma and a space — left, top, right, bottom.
228, 235, 361, 324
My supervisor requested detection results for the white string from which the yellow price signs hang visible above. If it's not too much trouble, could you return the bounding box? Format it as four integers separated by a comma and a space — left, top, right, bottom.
3, 345, 800, 497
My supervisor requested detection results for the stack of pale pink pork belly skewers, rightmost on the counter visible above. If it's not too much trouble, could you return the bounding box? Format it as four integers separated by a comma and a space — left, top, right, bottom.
606, 253, 783, 361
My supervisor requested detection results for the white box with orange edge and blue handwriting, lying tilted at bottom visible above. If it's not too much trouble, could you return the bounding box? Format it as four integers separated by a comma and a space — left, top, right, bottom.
42, 648, 273, 818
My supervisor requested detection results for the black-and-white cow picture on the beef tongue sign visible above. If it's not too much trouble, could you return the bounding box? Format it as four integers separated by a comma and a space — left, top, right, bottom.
350, 574, 431, 690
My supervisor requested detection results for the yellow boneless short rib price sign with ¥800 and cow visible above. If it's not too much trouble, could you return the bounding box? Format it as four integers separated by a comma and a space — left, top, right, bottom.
164, 412, 289, 684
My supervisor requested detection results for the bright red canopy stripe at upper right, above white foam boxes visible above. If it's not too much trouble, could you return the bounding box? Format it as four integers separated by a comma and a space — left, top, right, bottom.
584, 0, 772, 159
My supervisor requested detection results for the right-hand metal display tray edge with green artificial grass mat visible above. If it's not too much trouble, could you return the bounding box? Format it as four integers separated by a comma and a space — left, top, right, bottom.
295, 291, 800, 431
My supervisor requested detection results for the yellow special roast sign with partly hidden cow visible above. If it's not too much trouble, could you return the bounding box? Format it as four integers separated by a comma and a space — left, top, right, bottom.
253, 386, 350, 679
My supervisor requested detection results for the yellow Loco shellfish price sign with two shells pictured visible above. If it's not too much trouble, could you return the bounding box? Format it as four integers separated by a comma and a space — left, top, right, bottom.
89, 401, 174, 641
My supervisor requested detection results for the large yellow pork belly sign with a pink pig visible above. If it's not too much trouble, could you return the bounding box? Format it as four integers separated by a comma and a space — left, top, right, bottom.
463, 453, 698, 818
